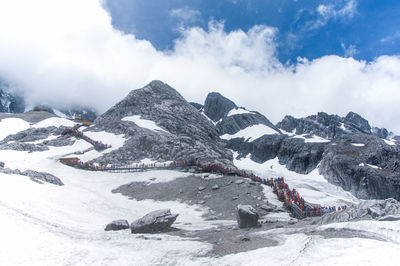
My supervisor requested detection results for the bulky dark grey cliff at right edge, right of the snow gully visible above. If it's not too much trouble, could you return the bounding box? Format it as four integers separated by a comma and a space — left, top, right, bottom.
319, 133, 400, 199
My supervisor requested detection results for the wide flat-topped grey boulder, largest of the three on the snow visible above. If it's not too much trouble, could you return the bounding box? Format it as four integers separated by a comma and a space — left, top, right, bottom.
131, 209, 179, 234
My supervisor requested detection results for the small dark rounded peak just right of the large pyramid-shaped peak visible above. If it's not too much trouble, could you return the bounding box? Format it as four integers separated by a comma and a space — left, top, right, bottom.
204, 92, 237, 122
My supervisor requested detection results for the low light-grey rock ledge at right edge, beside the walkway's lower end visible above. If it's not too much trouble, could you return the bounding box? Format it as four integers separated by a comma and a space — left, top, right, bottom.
316, 198, 400, 224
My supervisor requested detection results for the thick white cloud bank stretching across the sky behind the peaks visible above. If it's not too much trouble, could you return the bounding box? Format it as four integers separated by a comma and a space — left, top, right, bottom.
0, 0, 400, 132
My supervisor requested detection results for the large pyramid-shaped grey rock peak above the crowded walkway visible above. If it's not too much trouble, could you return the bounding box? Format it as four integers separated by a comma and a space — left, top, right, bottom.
88, 81, 233, 165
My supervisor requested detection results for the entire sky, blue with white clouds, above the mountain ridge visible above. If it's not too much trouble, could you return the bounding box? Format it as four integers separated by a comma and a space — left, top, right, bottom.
0, 0, 400, 134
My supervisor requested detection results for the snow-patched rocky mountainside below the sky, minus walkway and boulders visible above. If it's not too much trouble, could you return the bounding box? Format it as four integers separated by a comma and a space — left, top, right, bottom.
0, 81, 400, 265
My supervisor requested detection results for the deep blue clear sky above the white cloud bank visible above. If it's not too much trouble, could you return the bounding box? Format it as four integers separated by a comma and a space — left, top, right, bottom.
107, 0, 400, 63
